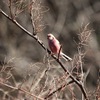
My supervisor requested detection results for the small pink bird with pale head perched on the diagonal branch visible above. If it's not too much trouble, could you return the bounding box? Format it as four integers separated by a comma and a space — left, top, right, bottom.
47, 34, 72, 61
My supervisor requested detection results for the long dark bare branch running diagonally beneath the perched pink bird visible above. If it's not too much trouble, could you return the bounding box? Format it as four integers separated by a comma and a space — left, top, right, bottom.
0, 9, 89, 100
